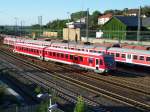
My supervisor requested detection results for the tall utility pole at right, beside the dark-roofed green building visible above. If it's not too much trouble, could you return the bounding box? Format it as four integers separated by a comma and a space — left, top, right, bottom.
137, 6, 141, 44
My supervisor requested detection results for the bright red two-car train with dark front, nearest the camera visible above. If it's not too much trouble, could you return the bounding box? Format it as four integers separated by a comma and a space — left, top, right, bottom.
14, 43, 116, 73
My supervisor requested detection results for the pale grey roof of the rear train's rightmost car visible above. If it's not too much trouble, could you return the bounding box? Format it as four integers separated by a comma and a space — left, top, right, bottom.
108, 47, 150, 55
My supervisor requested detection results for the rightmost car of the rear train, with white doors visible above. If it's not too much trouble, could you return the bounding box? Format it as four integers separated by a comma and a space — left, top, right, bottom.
107, 47, 150, 66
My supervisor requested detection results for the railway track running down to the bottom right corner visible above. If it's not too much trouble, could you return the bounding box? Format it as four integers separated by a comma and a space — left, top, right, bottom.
0, 48, 149, 111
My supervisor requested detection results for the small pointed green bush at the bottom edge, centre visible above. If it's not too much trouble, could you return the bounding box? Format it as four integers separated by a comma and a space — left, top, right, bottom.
74, 96, 86, 112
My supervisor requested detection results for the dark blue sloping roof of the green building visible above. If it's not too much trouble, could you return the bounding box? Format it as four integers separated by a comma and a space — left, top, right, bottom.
114, 16, 138, 27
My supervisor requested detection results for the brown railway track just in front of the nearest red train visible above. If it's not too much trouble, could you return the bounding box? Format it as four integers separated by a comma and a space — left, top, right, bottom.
45, 62, 150, 95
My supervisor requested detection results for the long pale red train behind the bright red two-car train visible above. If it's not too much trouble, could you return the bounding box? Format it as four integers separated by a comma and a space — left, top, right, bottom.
4, 37, 150, 66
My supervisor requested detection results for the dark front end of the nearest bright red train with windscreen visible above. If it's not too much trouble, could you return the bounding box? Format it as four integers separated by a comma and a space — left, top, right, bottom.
104, 55, 116, 73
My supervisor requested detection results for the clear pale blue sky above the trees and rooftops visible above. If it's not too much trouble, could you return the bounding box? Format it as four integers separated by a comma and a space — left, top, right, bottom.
0, 0, 150, 25
